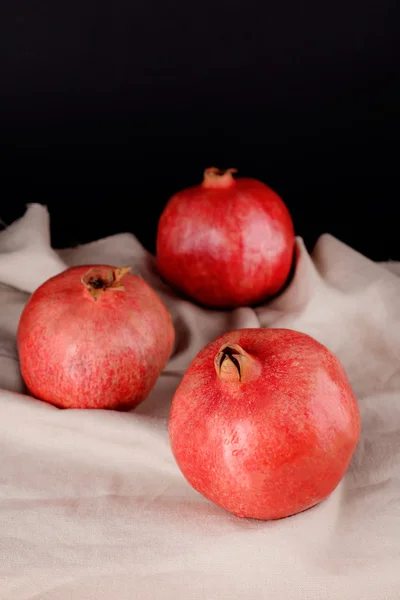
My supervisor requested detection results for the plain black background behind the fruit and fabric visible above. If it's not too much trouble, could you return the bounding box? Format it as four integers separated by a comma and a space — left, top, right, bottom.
0, 0, 400, 259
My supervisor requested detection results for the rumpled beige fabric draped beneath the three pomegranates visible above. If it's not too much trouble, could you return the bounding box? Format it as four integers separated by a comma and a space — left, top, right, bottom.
0, 205, 400, 600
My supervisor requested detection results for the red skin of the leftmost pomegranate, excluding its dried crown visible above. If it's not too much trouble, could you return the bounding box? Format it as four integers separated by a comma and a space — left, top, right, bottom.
17, 265, 174, 409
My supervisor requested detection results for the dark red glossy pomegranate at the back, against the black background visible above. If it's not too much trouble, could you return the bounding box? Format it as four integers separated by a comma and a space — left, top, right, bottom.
157, 167, 295, 308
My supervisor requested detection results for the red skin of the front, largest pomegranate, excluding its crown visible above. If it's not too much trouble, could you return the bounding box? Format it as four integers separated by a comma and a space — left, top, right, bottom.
169, 329, 360, 519
